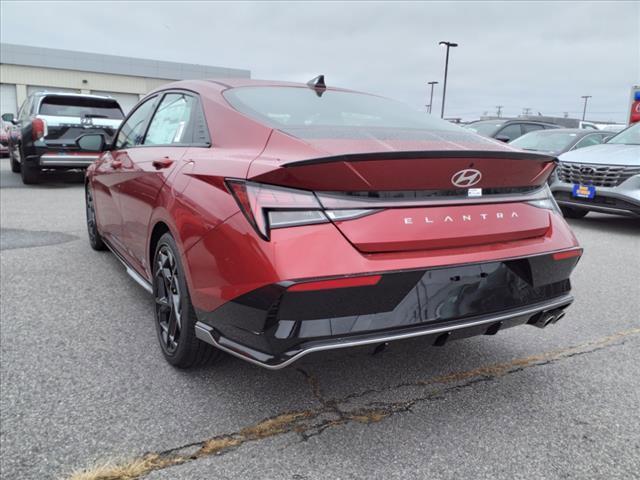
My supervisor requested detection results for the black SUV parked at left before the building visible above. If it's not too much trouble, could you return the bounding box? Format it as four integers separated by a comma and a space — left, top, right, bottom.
2, 92, 124, 184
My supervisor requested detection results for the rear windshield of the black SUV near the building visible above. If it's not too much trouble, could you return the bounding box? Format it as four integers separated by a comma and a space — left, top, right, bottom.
40, 95, 124, 119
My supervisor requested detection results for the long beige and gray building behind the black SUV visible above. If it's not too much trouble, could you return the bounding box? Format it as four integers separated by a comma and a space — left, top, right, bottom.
0, 43, 251, 114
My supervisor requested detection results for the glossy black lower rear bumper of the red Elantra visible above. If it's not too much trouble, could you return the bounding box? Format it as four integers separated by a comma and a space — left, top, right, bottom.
196, 254, 579, 369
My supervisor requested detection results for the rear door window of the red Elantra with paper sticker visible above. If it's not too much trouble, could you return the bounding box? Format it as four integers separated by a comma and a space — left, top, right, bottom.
144, 93, 196, 145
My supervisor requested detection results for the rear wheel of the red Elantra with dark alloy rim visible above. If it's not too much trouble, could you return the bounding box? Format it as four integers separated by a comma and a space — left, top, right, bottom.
153, 233, 222, 368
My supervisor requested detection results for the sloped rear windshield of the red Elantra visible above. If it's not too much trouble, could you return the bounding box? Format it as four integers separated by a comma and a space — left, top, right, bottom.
224, 87, 461, 131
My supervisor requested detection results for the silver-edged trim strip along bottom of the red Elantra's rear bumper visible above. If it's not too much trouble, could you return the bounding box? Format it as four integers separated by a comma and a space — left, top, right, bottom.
195, 295, 573, 370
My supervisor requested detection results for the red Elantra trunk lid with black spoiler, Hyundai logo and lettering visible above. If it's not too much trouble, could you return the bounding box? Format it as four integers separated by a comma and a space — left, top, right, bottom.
248, 132, 555, 253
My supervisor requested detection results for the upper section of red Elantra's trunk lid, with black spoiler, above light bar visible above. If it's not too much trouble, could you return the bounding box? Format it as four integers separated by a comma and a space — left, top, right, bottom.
248, 129, 555, 192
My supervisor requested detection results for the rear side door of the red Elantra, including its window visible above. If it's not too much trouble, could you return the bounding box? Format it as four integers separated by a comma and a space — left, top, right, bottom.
118, 91, 200, 271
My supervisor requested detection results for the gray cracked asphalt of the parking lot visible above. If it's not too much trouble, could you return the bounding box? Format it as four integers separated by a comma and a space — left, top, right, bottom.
0, 159, 640, 480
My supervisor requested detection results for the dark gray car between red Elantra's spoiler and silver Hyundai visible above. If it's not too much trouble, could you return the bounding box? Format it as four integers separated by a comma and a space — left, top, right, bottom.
509, 128, 614, 156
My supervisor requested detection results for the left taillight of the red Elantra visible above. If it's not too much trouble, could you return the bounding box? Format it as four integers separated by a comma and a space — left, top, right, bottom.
226, 179, 377, 240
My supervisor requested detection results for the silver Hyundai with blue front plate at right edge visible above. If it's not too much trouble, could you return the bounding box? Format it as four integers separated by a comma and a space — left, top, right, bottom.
551, 124, 640, 218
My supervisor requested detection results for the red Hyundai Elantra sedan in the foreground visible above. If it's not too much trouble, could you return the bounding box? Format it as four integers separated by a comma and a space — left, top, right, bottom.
83, 78, 582, 369
